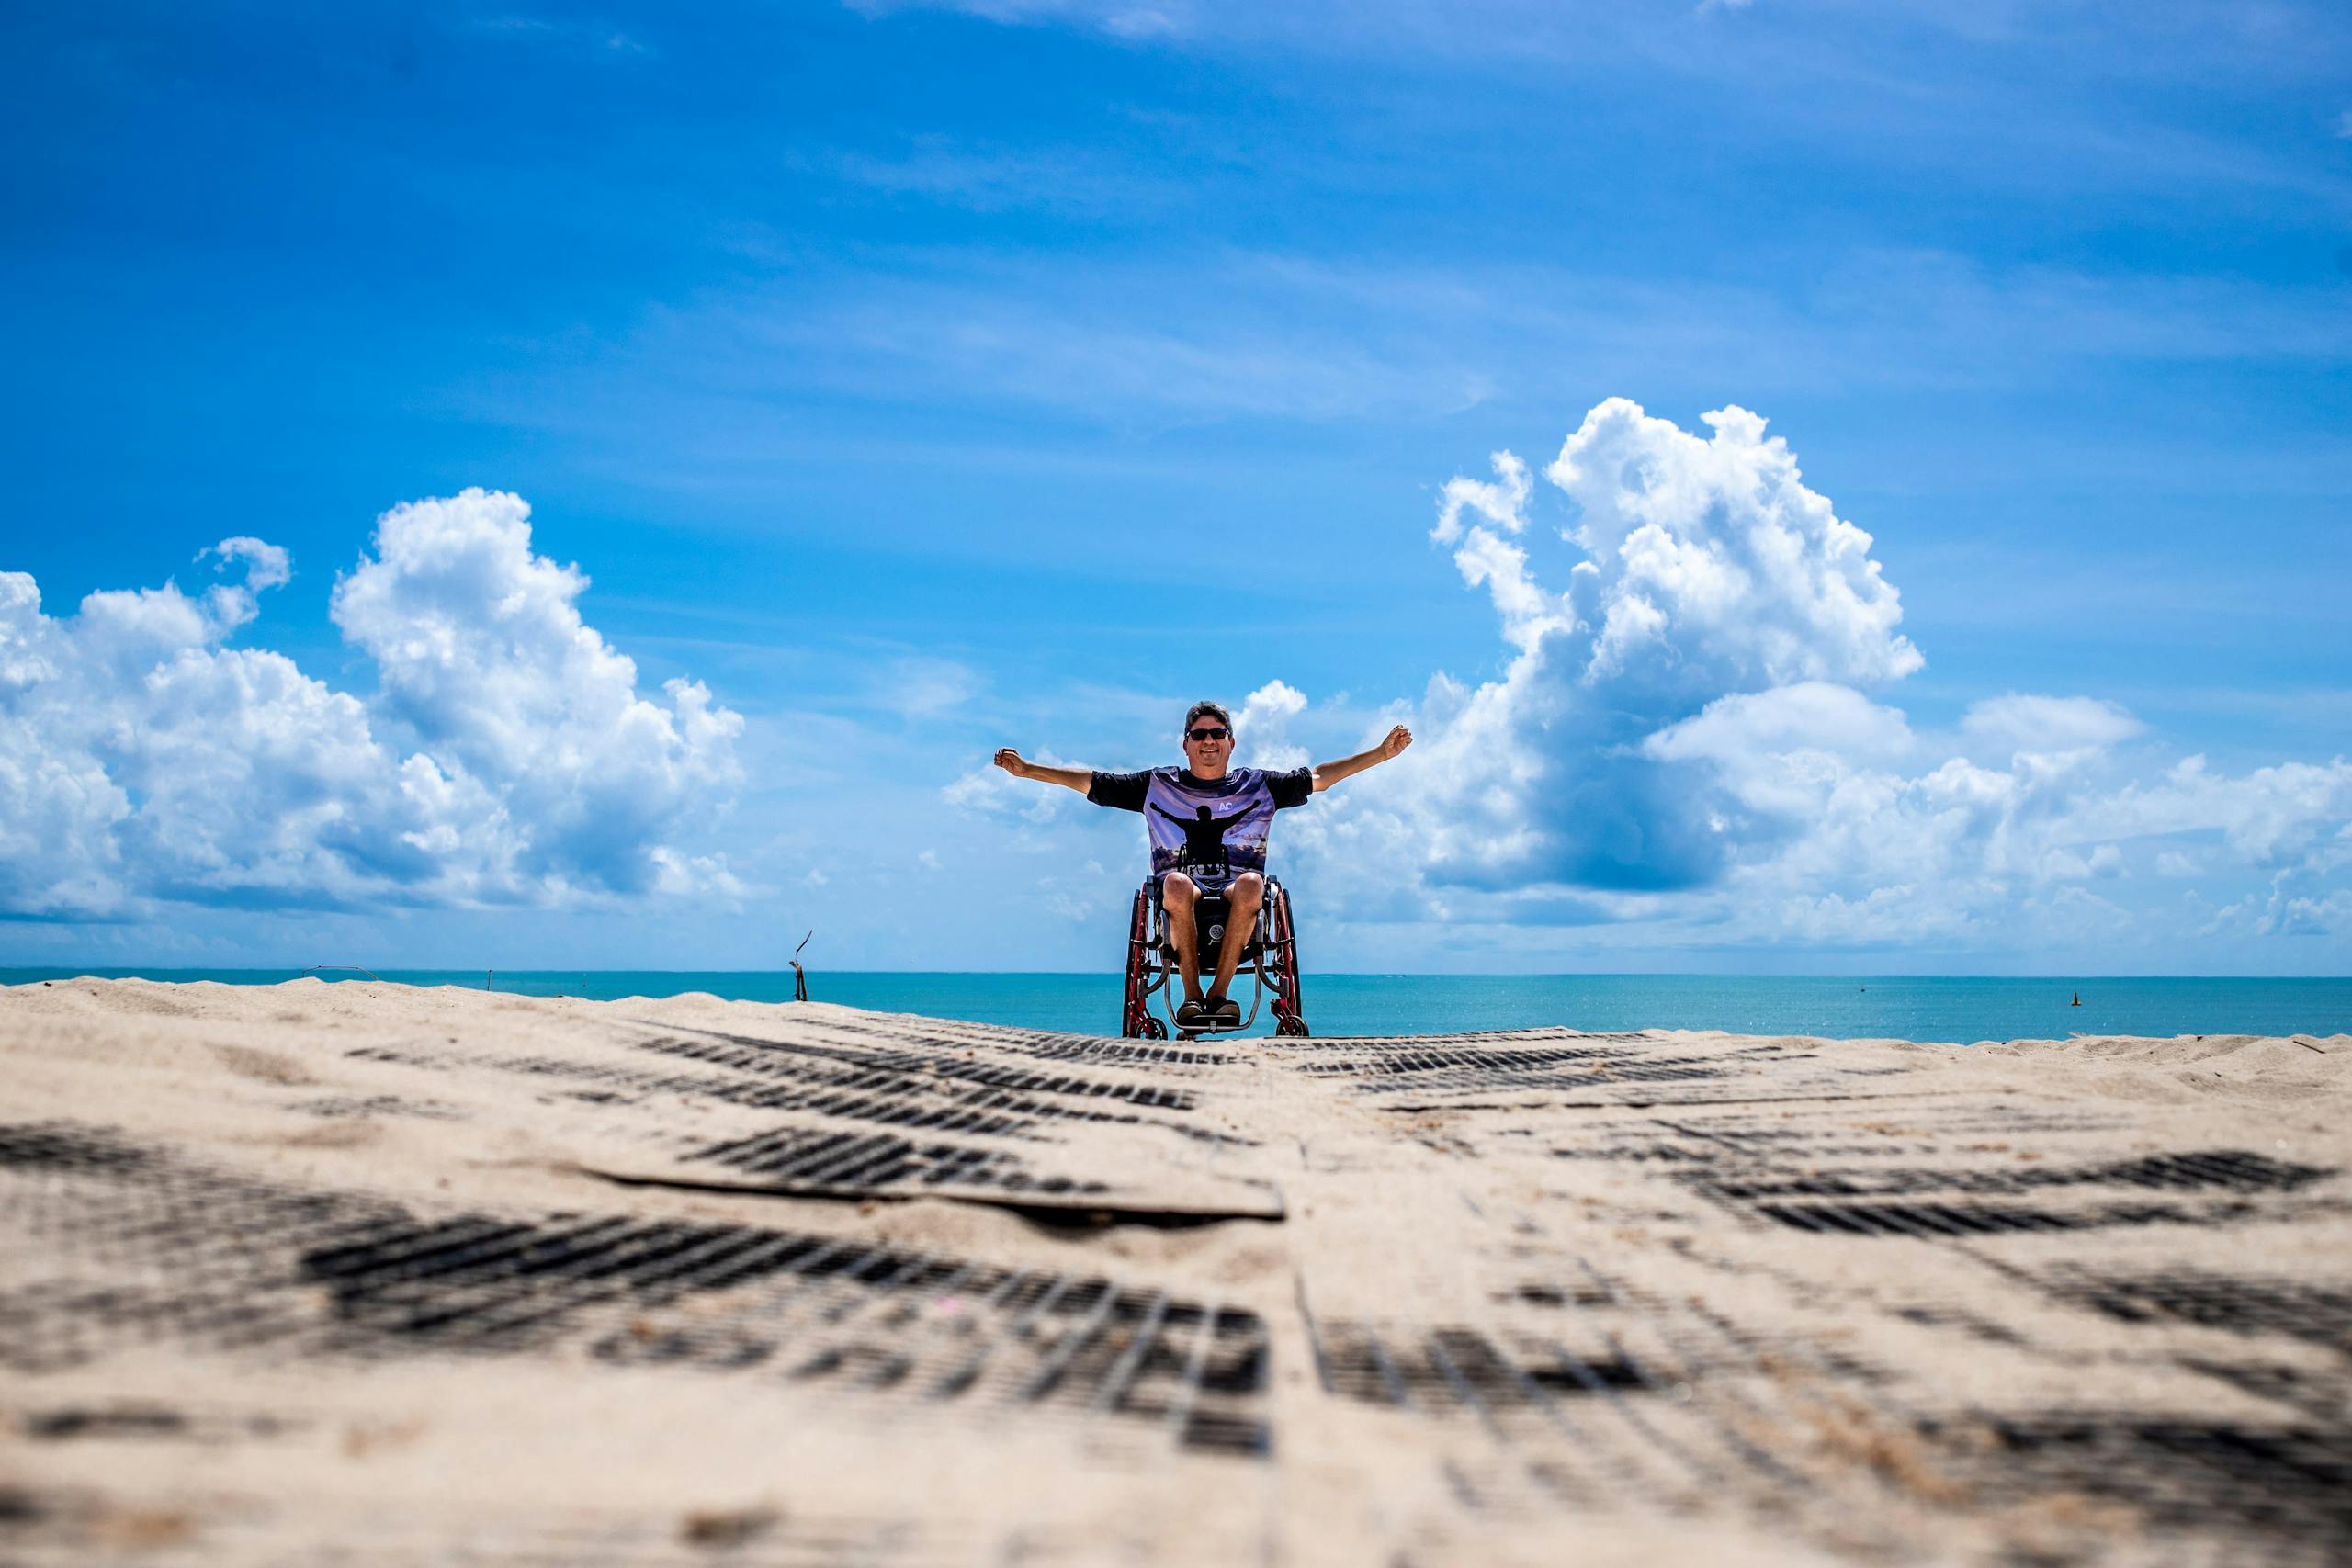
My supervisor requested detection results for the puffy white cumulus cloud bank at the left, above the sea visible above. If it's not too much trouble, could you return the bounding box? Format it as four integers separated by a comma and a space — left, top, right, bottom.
0, 489, 741, 919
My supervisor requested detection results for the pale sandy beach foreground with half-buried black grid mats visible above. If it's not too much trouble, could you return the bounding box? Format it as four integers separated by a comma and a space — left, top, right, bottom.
0, 980, 2352, 1568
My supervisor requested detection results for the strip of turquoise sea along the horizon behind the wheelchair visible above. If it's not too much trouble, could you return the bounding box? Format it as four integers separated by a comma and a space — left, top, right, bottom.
0, 968, 2352, 1042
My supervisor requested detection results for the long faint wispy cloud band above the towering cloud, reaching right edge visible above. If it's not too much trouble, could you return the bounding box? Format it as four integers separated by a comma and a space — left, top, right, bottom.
470, 252, 2352, 466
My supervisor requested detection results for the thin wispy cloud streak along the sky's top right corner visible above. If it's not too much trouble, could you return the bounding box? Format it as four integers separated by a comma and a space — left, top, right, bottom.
854, 0, 2352, 211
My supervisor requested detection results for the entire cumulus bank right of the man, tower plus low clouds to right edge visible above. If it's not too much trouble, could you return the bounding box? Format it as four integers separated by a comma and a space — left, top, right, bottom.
1284, 400, 2352, 945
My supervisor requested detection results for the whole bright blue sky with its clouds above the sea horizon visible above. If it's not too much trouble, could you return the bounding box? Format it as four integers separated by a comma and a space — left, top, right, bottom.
0, 0, 2352, 974
